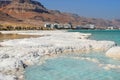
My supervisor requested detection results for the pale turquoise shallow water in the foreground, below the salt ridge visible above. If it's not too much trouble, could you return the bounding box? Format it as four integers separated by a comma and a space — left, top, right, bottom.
26, 58, 120, 80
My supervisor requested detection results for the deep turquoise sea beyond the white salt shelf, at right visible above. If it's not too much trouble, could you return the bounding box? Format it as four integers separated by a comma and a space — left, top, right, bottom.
69, 30, 120, 45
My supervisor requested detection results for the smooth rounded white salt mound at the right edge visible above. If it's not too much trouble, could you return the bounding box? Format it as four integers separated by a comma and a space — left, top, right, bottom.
106, 47, 120, 59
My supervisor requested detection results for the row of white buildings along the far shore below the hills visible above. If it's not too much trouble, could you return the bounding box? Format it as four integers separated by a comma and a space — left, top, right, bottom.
44, 23, 120, 30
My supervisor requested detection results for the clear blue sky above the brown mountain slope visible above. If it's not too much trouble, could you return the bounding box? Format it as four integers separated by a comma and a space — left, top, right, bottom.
38, 0, 120, 19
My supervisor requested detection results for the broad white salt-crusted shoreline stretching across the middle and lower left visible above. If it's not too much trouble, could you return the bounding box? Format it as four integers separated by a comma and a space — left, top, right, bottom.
0, 31, 115, 80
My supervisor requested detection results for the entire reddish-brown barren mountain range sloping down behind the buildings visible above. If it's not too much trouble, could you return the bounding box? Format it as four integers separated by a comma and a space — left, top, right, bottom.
0, 0, 120, 30
